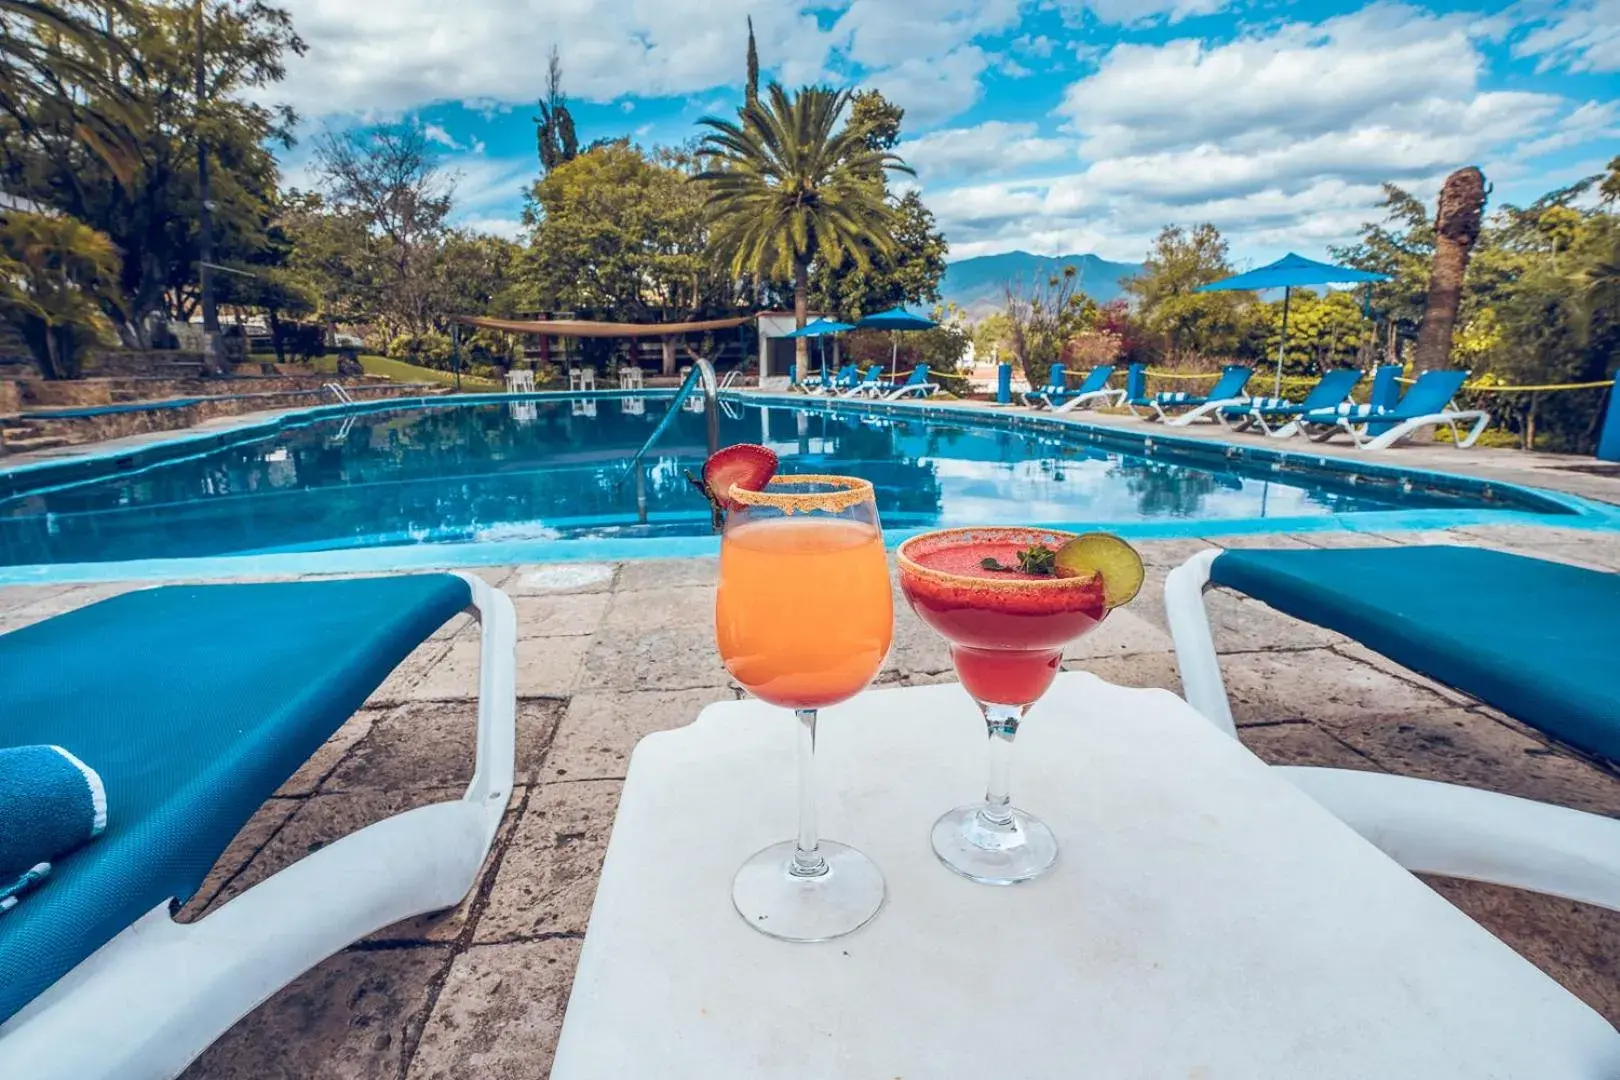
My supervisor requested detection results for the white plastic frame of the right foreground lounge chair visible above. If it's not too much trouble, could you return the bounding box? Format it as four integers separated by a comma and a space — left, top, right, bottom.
1165, 551, 1620, 910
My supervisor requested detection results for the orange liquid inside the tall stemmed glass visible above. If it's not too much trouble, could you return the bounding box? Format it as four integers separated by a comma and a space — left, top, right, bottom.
714, 515, 894, 709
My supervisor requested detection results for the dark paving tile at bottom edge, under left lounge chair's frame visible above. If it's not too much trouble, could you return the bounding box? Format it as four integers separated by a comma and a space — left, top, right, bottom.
181, 945, 450, 1080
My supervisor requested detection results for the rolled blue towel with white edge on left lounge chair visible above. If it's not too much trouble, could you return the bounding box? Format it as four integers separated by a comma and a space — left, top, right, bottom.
0, 746, 107, 893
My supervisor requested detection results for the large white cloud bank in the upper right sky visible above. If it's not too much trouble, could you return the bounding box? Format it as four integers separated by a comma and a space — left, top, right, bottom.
907, 3, 1587, 259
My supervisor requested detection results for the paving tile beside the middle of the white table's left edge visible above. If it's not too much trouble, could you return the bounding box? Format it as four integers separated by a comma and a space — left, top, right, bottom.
475, 780, 624, 944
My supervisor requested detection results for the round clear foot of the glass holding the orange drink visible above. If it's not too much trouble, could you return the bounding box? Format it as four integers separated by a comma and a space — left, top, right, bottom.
731, 840, 888, 941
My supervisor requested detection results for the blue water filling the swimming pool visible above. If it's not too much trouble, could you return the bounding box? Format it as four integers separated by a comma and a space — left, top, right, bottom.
0, 397, 1568, 565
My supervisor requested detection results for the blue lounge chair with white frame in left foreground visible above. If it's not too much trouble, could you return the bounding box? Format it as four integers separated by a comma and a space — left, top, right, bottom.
0, 573, 517, 1080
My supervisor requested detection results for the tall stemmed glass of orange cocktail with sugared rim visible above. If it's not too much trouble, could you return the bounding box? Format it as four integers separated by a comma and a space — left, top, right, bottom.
714, 476, 894, 941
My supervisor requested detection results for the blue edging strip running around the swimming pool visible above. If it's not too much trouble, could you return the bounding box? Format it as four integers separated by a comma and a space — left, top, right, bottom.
0, 389, 1620, 585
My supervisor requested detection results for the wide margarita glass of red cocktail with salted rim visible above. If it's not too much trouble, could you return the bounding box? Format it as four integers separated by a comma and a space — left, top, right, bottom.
897, 528, 1108, 884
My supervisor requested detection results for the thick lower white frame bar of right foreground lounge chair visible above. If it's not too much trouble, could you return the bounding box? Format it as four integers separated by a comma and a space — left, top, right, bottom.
1278, 766, 1620, 912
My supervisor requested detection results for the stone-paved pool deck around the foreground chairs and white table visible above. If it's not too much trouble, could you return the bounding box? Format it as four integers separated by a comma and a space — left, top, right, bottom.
0, 521, 1620, 1080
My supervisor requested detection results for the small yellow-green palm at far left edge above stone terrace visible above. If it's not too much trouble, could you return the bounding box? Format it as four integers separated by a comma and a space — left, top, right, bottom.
0, 212, 120, 379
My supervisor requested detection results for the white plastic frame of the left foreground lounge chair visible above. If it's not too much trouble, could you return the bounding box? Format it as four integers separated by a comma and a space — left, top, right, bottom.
0, 573, 517, 1080
